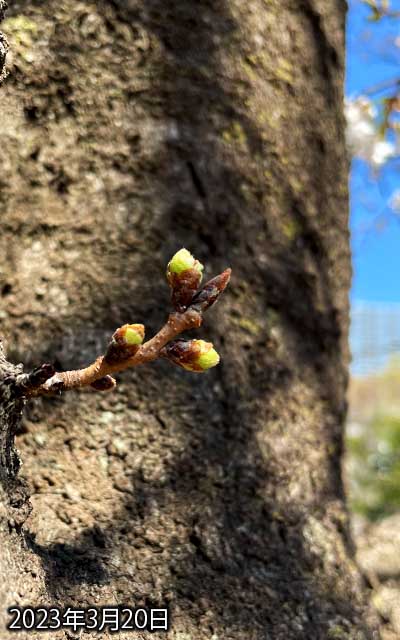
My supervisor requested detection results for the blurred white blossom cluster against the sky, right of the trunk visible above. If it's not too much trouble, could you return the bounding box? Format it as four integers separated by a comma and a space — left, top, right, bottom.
345, 96, 396, 168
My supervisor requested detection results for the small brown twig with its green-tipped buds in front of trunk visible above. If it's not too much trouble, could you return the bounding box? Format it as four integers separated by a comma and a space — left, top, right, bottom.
16, 249, 231, 398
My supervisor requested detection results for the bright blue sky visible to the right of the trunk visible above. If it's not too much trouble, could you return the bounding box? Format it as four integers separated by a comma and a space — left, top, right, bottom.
346, 0, 400, 303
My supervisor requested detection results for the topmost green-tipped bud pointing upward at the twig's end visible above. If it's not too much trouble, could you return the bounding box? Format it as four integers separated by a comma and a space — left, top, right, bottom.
167, 249, 204, 312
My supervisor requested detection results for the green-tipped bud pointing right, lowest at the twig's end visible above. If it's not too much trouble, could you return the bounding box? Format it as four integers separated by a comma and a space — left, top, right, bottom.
162, 340, 220, 373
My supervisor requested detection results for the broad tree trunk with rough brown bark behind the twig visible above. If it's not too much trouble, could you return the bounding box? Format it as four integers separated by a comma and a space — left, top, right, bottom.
0, 0, 377, 640
